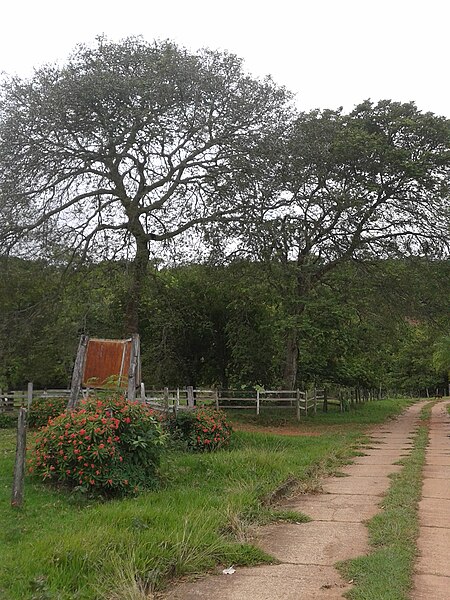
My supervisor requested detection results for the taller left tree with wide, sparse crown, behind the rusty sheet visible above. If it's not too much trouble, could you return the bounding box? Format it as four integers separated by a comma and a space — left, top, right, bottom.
0, 38, 288, 333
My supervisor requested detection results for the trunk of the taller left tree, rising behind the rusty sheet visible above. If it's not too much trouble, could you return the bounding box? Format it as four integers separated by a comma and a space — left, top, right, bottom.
124, 239, 150, 337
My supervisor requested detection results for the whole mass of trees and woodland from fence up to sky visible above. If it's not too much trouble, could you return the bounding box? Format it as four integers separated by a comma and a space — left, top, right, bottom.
0, 37, 450, 394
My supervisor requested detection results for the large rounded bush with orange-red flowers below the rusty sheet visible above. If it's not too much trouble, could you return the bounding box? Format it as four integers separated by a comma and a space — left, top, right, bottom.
29, 398, 164, 496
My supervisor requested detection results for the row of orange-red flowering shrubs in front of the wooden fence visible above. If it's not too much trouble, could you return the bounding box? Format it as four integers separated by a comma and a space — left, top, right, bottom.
29, 397, 231, 496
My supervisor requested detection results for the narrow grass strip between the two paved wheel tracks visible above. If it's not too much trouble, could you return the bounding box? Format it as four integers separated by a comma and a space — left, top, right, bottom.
339, 410, 432, 600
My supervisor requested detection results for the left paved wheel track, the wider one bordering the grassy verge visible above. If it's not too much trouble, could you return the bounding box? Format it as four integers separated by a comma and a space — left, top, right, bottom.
165, 404, 424, 600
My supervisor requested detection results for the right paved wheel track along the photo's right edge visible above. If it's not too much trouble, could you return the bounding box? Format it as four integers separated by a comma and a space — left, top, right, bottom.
412, 402, 450, 600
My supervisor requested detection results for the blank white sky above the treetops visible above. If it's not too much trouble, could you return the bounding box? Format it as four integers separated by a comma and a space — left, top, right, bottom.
0, 0, 450, 117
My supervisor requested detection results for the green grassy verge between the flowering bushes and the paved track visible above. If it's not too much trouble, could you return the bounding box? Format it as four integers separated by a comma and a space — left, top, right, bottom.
0, 401, 414, 600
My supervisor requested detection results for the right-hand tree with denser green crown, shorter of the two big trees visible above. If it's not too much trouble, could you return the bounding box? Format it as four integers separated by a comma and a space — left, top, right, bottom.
229, 100, 450, 389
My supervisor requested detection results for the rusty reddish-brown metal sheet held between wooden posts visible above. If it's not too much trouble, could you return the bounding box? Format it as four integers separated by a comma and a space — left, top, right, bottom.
83, 338, 131, 389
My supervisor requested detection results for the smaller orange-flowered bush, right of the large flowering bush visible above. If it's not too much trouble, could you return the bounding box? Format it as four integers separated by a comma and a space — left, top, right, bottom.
168, 408, 232, 452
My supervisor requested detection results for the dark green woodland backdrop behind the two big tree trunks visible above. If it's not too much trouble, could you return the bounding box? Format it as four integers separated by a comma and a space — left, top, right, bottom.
0, 259, 450, 396
